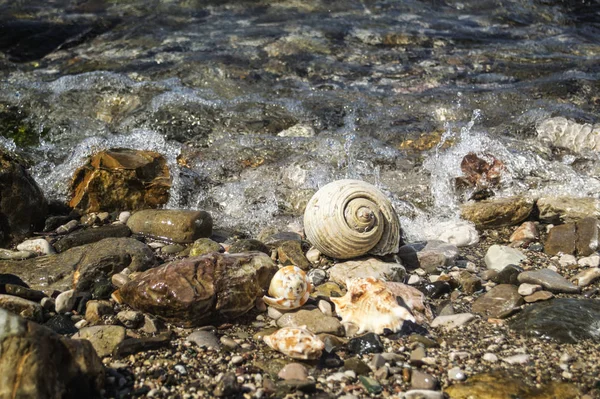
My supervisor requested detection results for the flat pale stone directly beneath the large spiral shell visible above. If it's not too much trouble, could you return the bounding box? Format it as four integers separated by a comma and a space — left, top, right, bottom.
328, 258, 406, 287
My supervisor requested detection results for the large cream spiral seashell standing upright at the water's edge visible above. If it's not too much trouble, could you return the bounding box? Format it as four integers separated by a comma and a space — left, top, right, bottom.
304, 179, 400, 259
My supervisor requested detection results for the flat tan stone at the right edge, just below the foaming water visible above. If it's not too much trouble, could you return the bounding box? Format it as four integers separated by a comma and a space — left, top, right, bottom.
536, 197, 600, 223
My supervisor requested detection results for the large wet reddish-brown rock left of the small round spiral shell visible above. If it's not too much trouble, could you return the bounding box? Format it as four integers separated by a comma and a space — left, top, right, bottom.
119, 252, 277, 327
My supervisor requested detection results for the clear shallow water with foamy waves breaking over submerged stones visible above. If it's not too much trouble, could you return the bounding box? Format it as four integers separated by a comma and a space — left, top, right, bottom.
0, 0, 600, 238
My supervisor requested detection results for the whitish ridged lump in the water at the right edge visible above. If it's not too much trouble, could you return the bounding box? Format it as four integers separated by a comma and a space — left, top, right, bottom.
537, 117, 600, 152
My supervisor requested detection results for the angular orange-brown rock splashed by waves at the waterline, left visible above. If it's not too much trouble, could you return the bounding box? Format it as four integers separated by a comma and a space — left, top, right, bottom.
69, 148, 171, 212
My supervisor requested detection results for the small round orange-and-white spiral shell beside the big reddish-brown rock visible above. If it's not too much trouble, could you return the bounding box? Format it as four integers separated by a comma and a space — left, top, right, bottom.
263, 266, 312, 310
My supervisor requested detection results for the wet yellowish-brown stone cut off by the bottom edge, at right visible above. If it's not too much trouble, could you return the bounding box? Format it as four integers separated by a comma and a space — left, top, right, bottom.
444, 372, 579, 399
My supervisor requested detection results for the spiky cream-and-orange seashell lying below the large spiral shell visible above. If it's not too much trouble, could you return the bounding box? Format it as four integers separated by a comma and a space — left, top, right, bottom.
331, 277, 416, 334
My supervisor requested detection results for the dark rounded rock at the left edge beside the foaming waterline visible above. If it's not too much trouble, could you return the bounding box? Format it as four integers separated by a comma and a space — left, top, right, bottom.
0, 151, 48, 244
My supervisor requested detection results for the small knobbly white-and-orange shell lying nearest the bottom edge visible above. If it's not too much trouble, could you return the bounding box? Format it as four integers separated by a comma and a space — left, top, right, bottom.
263, 326, 325, 359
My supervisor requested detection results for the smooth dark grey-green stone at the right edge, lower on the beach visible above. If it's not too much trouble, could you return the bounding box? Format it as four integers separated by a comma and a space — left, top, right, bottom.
509, 298, 600, 343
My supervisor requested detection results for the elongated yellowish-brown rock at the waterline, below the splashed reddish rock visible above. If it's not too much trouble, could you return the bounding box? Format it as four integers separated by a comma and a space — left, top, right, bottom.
461, 197, 533, 228
